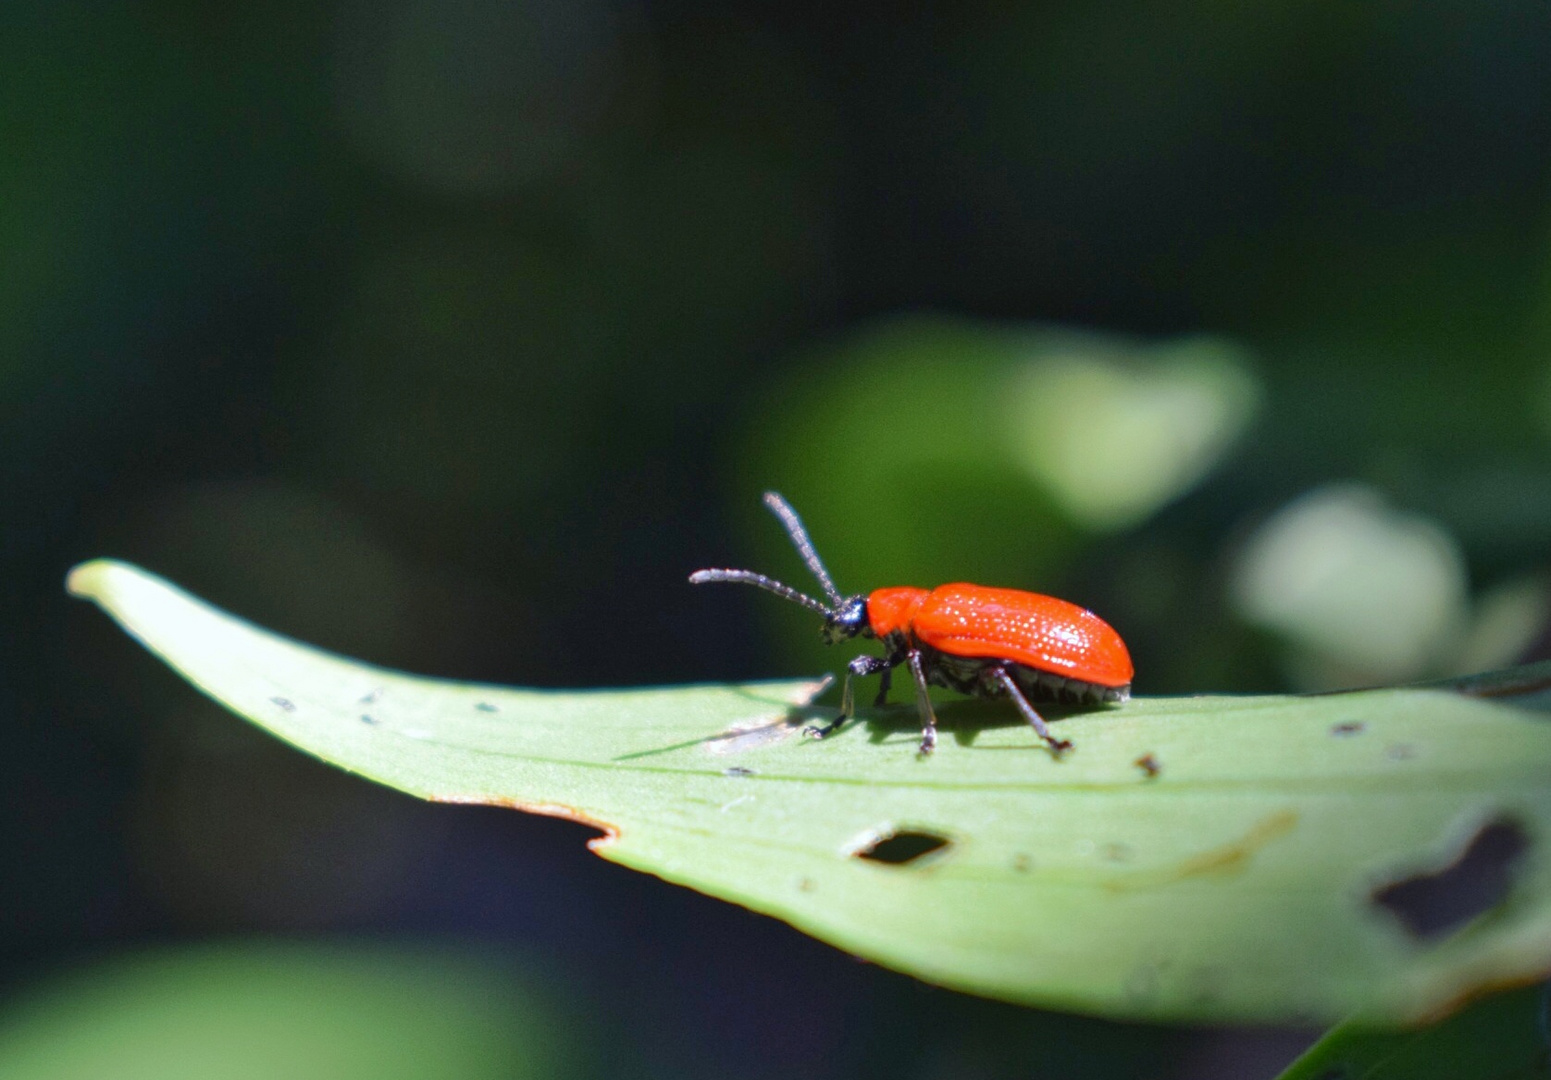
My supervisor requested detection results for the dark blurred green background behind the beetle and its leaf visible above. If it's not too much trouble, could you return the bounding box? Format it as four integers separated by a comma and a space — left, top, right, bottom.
9, 0, 1551, 1080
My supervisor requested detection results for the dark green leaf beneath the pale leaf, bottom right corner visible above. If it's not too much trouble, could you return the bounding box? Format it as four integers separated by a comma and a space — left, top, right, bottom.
1278, 987, 1551, 1080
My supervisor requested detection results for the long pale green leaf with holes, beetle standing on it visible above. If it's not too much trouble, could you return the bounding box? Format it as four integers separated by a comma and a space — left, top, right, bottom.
70, 562, 1551, 1023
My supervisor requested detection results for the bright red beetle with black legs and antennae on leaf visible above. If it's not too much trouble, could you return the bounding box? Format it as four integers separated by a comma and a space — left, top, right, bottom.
689, 492, 1134, 757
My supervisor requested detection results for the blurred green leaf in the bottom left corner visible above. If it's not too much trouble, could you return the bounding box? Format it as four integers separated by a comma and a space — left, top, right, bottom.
0, 942, 575, 1080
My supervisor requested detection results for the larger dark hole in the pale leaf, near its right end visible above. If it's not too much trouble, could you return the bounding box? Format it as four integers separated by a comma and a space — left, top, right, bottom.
1373, 818, 1529, 940
